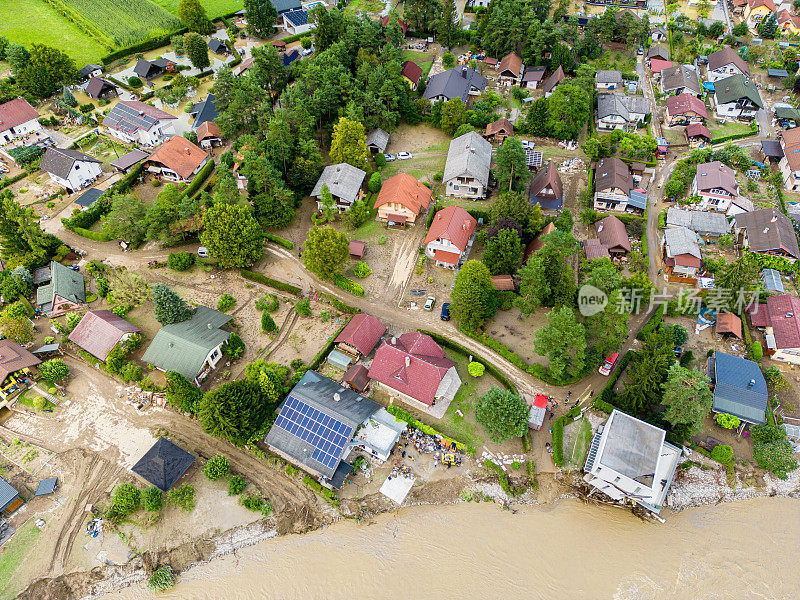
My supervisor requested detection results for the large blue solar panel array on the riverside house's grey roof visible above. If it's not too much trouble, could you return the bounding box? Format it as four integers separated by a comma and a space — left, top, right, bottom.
275, 396, 353, 469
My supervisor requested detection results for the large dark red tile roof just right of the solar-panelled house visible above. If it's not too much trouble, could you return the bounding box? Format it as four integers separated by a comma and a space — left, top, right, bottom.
369, 332, 456, 406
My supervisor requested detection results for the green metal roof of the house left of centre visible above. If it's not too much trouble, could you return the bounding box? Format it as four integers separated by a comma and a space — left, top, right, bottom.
142, 306, 233, 381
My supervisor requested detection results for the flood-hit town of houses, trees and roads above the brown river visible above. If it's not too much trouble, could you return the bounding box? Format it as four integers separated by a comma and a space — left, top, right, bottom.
0, 0, 800, 600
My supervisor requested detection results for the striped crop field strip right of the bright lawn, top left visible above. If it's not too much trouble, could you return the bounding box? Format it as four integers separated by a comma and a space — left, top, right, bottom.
62, 0, 181, 48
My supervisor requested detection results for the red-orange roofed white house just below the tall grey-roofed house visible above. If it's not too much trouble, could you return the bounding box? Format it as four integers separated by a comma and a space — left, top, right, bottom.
423, 205, 478, 269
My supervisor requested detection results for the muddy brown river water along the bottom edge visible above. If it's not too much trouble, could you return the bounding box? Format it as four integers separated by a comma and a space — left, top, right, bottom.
104, 498, 800, 600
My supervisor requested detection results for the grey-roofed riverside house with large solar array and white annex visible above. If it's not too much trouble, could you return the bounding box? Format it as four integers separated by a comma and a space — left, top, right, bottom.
264, 371, 406, 490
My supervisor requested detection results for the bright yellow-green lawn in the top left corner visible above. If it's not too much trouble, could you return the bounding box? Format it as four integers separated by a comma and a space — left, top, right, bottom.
0, 0, 108, 67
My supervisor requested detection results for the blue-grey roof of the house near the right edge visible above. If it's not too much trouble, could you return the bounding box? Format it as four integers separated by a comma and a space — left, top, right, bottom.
708, 351, 768, 423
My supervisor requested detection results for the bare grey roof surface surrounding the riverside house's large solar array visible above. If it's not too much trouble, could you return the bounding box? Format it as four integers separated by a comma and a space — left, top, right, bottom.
264, 371, 380, 478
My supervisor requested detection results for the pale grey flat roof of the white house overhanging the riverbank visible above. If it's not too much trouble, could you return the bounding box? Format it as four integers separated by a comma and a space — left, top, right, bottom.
597, 410, 664, 486
